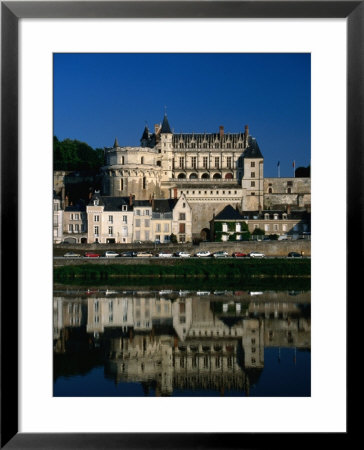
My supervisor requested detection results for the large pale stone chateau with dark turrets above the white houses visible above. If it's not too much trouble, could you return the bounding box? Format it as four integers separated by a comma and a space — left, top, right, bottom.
102, 115, 311, 238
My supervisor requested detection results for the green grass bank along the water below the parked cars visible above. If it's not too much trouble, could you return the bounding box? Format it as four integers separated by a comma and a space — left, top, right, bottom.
54, 259, 311, 282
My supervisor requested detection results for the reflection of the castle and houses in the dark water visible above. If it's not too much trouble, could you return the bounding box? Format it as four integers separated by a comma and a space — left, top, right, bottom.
54, 291, 311, 395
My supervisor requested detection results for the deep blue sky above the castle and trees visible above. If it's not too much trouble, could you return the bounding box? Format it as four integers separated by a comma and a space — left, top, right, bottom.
53, 53, 311, 177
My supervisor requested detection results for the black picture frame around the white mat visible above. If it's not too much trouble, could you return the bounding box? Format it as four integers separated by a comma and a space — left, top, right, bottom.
1, 0, 356, 449
